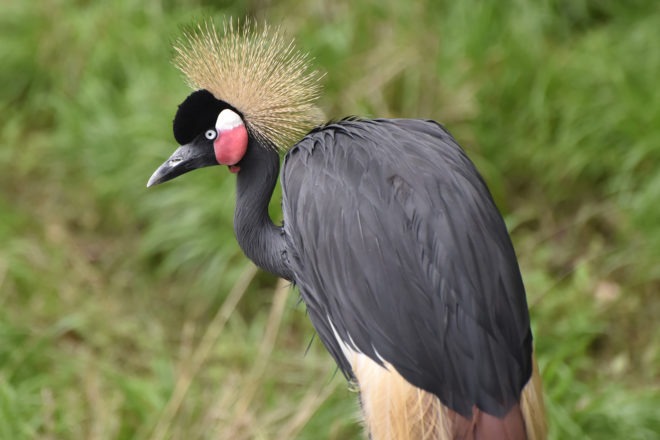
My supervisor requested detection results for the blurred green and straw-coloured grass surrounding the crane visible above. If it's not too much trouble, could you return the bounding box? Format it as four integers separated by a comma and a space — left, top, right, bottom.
0, 0, 660, 439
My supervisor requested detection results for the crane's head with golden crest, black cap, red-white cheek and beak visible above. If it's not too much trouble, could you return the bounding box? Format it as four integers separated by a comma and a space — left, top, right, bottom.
147, 21, 322, 187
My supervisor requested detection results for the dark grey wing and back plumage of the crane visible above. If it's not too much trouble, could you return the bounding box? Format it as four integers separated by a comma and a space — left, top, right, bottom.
282, 120, 532, 417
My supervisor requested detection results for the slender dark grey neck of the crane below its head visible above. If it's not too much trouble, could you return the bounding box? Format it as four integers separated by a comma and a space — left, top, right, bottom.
234, 140, 293, 280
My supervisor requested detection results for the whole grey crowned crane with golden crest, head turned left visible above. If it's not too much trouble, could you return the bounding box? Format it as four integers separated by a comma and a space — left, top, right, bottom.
147, 21, 545, 440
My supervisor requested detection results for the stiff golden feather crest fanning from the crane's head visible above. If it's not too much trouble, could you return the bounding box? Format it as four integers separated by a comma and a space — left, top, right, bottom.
174, 20, 323, 150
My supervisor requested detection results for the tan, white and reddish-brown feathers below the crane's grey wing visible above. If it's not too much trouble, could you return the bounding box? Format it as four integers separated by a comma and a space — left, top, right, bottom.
340, 344, 547, 440
